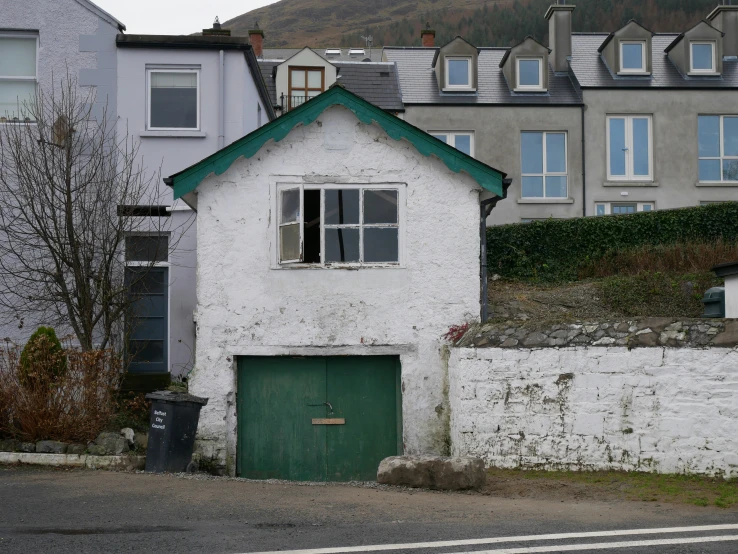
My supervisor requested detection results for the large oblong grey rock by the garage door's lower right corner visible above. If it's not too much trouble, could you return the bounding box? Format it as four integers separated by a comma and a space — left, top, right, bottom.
377, 456, 486, 491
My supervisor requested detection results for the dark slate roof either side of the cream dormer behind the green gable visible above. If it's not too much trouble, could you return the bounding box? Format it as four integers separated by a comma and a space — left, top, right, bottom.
259, 59, 404, 111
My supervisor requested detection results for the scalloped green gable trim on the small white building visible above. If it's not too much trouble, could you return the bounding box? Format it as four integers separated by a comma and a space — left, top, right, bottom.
165, 86, 505, 200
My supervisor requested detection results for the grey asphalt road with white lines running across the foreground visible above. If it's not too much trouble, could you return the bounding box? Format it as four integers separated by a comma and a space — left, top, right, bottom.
0, 468, 738, 554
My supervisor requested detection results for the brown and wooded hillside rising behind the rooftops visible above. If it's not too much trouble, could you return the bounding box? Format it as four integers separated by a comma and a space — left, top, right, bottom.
224, 0, 718, 48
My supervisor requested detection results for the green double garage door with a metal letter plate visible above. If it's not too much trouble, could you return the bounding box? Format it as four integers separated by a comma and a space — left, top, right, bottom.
237, 356, 402, 481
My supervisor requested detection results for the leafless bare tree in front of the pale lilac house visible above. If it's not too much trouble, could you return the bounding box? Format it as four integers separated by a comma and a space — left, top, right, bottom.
0, 76, 183, 350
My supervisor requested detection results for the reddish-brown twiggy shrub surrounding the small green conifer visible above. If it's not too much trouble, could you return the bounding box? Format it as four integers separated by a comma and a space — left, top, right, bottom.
0, 342, 123, 442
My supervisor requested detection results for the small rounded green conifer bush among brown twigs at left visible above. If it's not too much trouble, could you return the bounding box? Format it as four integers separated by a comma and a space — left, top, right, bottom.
18, 327, 67, 388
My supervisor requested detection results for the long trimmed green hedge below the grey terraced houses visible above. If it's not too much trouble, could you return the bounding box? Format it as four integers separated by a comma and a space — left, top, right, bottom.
487, 202, 738, 282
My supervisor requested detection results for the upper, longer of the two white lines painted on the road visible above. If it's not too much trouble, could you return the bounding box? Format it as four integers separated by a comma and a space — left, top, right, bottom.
244, 524, 738, 554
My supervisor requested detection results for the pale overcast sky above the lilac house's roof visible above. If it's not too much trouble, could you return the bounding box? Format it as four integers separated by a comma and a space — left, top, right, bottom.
92, 0, 276, 35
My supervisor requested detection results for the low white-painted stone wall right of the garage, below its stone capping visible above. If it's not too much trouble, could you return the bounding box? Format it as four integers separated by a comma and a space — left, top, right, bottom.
449, 347, 738, 476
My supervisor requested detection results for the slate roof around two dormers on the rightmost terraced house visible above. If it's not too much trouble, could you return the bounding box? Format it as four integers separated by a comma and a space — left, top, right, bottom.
571, 33, 738, 89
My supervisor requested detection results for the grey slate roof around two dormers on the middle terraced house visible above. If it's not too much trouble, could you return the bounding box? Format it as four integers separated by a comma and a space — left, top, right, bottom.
384, 46, 580, 106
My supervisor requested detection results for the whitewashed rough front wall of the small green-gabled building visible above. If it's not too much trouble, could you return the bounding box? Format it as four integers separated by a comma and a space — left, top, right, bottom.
190, 107, 480, 473
